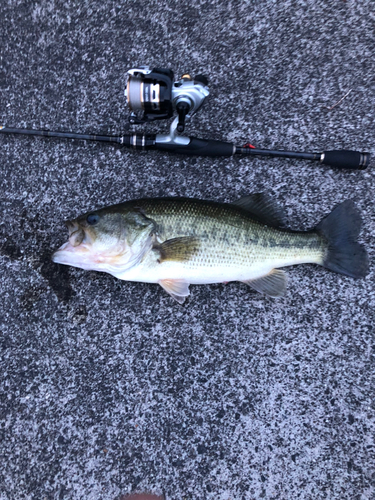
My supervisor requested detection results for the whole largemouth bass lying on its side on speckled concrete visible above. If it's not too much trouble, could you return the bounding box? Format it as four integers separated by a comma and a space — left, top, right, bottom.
52, 193, 369, 304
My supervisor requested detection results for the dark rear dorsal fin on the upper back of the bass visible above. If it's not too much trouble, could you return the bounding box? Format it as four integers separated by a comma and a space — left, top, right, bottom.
232, 193, 285, 227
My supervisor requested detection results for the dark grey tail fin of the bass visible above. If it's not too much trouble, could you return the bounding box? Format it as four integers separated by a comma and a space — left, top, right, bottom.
316, 200, 369, 278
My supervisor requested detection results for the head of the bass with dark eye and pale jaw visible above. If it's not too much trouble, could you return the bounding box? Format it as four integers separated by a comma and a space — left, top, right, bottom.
52, 209, 153, 275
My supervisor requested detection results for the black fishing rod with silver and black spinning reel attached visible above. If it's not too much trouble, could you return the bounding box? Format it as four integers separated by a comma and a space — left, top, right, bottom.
0, 66, 370, 170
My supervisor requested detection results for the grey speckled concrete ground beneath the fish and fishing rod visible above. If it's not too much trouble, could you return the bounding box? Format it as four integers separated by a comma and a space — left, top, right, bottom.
0, 0, 375, 500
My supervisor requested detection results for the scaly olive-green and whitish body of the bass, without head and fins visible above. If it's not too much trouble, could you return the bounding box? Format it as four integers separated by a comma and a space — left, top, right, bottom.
108, 199, 324, 283
